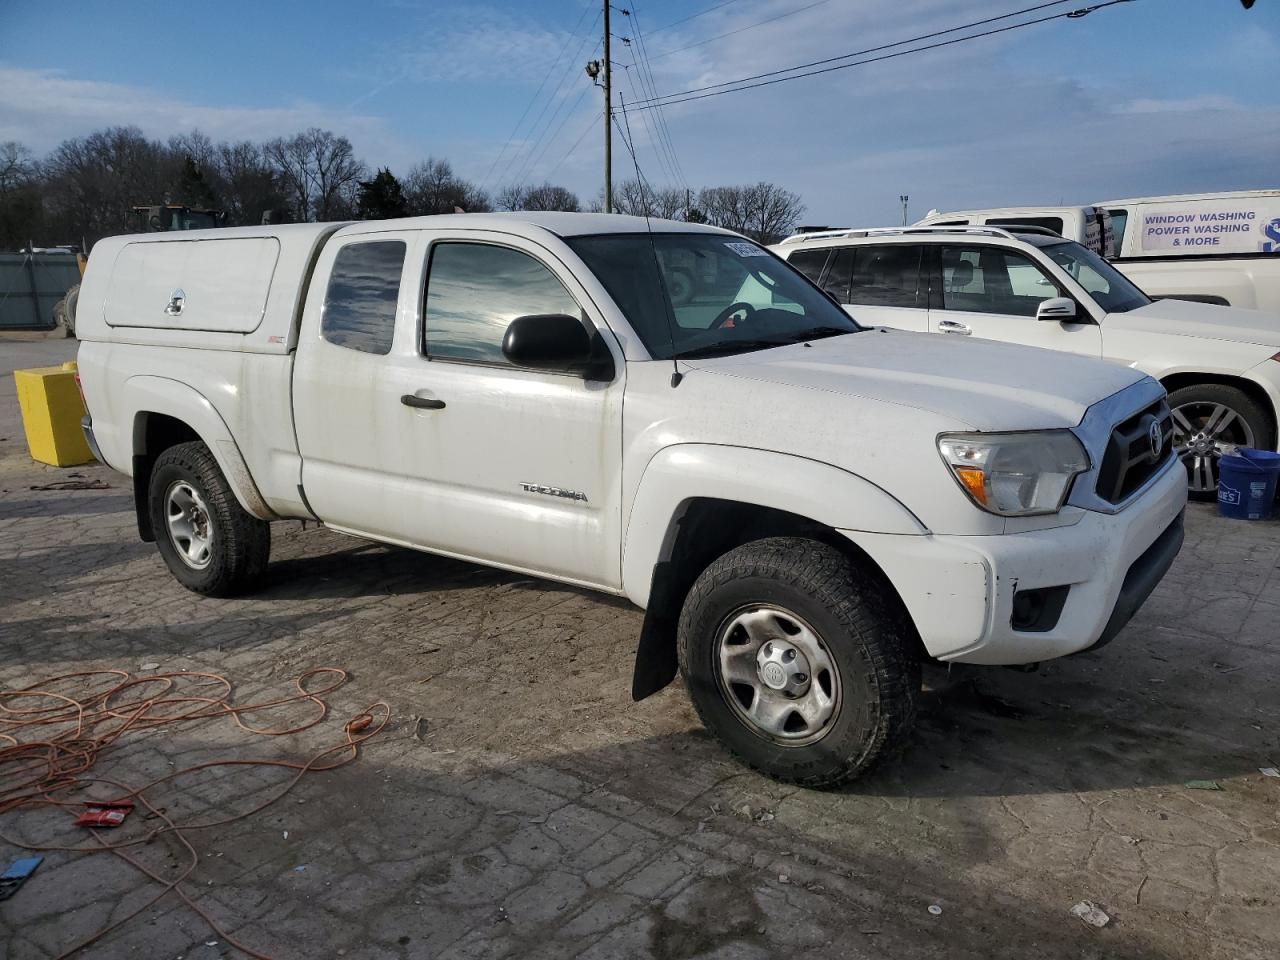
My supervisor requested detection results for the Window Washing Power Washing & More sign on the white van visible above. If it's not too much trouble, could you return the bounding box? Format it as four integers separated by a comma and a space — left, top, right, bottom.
1142, 202, 1280, 253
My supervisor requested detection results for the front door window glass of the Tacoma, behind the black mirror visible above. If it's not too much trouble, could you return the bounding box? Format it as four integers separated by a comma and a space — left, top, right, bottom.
424, 242, 582, 364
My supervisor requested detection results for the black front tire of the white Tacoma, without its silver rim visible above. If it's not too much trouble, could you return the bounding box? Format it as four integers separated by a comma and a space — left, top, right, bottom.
677, 538, 920, 787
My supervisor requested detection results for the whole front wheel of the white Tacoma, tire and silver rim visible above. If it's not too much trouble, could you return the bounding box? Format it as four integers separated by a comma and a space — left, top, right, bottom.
678, 538, 920, 787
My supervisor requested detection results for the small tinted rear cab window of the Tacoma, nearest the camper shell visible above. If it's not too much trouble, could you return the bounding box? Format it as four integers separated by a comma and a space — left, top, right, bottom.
320, 241, 404, 353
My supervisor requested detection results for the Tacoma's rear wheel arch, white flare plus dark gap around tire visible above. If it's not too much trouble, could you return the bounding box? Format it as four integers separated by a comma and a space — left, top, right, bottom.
124, 376, 275, 541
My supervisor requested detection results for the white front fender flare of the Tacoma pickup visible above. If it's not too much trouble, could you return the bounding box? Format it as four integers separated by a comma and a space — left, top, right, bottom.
622, 443, 928, 607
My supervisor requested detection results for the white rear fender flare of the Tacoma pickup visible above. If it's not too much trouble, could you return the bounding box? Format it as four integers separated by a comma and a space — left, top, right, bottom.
123, 375, 278, 520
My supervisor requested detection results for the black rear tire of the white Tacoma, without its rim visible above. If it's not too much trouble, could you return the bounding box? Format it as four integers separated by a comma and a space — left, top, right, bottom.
147, 440, 271, 596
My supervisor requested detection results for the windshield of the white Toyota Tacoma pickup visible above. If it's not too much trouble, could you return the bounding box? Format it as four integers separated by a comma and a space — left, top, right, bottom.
566, 233, 860, 360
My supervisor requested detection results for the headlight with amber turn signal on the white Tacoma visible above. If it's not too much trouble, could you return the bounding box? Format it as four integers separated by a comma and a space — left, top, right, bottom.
938, 430, 1089, 517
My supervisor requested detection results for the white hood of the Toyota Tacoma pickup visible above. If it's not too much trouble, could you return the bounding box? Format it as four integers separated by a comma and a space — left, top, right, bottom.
681, 328, 1146, 430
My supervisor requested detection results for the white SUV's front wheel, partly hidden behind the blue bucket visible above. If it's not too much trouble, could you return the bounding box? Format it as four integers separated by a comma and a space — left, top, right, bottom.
1169, 383, 1275, 499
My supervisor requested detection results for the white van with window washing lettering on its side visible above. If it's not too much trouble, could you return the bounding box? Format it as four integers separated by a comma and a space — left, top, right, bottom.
1100, 189, 1280, 314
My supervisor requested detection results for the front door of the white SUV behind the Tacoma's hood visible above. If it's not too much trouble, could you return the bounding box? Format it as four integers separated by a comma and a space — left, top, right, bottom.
929, 243, 1102, 357
